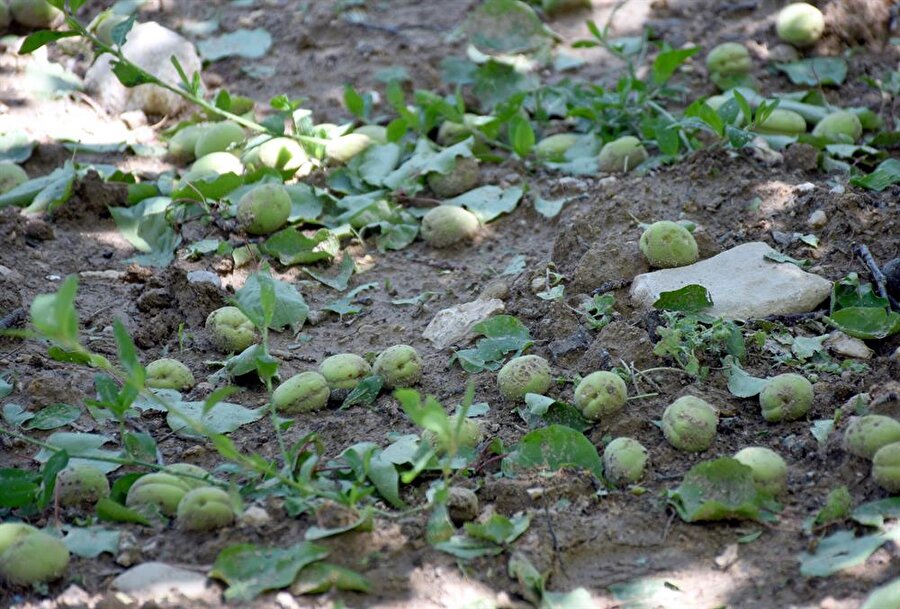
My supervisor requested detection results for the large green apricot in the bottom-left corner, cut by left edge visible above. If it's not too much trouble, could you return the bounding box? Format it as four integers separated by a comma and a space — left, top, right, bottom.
0, 531, 69, 586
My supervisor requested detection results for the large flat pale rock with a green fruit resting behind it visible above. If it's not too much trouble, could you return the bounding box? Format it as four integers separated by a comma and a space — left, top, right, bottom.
631, 242, 831, 319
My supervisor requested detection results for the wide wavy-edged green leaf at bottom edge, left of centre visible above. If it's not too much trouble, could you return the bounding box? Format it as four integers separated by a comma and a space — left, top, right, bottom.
209, 541, 328, 601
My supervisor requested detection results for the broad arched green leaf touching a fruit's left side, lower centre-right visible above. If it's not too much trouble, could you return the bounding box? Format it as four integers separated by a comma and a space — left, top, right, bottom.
502, 425, 603, 480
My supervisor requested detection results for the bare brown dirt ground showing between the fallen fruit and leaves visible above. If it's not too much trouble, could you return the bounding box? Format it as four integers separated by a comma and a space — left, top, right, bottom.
0, 0, 900, 609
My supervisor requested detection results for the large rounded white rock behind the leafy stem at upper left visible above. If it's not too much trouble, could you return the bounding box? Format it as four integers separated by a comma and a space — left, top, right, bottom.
85, 22, 201, 114
